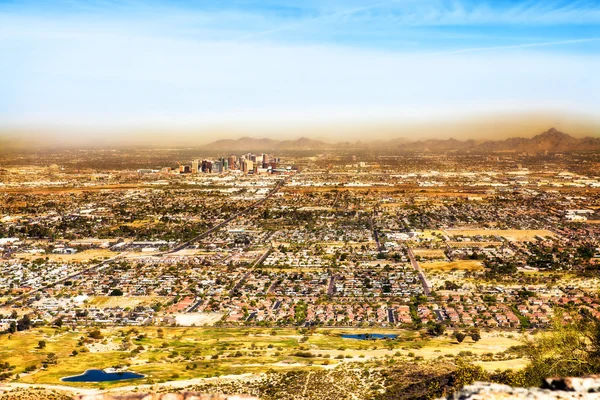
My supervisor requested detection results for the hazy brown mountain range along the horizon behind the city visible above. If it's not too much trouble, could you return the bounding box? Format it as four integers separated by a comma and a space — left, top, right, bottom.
203, 128, 600, 153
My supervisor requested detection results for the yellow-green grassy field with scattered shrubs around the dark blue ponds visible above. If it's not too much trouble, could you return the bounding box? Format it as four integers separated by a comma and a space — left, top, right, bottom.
0, 327, 519, 388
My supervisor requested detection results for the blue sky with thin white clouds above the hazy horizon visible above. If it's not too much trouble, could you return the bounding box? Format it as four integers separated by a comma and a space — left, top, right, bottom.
0, 0, 600, 142
